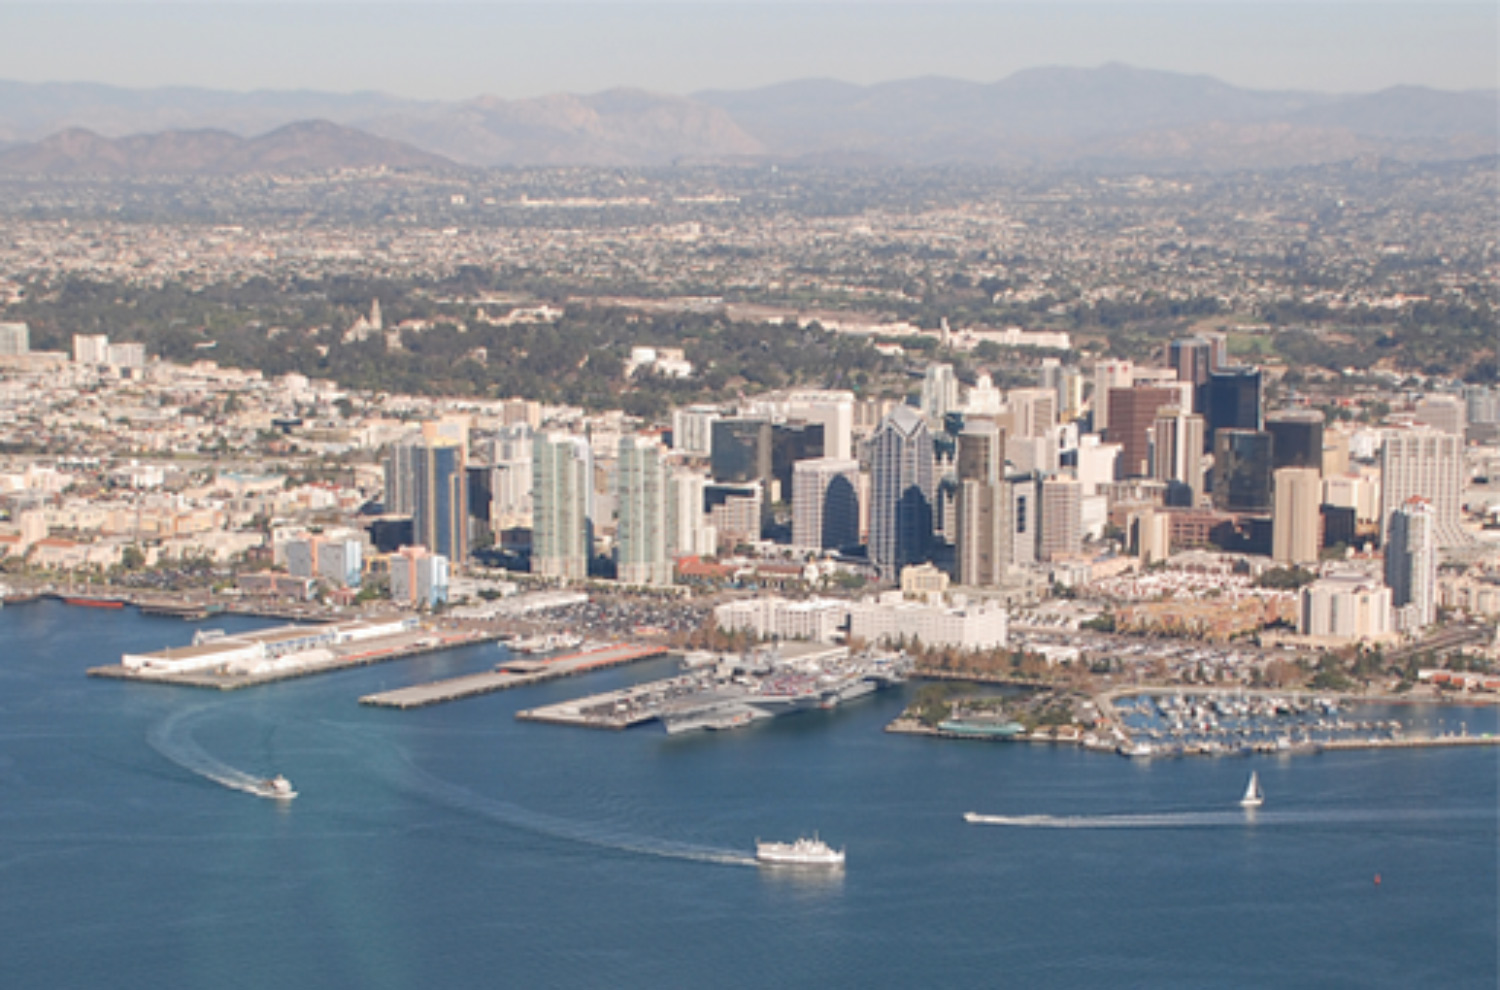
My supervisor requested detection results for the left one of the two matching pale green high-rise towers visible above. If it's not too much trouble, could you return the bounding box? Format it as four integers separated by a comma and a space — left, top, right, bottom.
531, 432, 594, 581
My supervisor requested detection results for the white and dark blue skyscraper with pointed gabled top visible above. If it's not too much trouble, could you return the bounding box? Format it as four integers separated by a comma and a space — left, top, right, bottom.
870, 405, 938, 578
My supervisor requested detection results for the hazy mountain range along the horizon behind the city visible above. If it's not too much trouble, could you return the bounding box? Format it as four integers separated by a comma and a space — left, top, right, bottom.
0, 65, 1500, 174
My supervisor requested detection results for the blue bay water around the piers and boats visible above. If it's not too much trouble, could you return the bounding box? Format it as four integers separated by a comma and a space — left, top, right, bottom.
0, 603, 1500, 989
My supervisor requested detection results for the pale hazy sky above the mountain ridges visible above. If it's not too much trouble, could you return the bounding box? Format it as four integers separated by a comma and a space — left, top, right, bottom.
0, 0, 1500, 99
